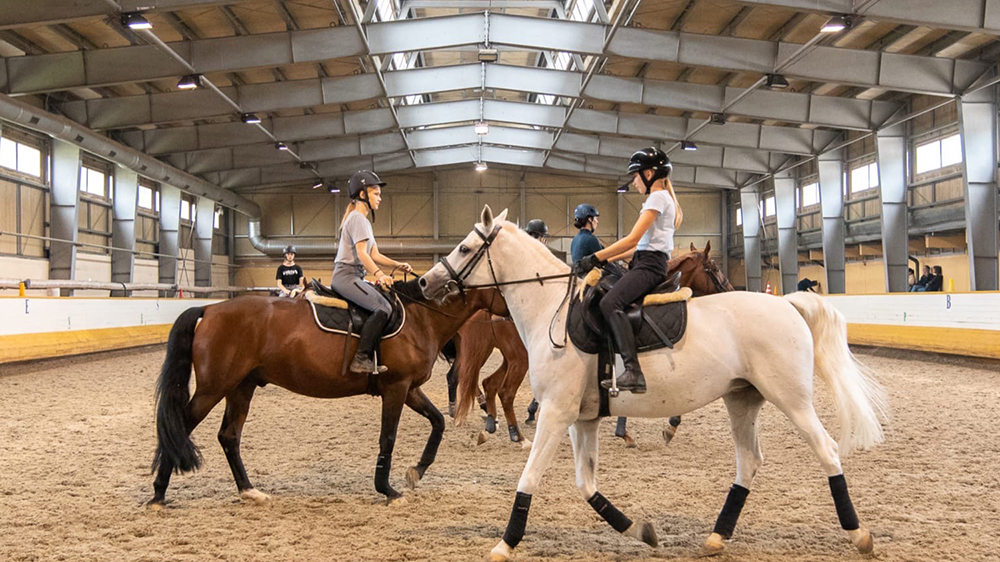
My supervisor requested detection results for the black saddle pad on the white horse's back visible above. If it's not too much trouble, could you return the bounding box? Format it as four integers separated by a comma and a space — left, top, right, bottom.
566, 266, 687, 353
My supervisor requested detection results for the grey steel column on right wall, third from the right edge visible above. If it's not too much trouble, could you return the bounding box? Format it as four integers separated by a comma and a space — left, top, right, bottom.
819, 150, 847, 294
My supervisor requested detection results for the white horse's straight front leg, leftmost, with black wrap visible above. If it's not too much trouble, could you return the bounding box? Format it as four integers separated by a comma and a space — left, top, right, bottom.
490, 396, 580, 562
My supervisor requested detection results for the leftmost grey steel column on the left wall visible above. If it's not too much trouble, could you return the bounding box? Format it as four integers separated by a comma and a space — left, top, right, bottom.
49, 139, 80, 296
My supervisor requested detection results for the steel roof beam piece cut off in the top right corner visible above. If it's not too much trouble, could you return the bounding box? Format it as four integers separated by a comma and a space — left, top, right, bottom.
742, 0, 1000, 35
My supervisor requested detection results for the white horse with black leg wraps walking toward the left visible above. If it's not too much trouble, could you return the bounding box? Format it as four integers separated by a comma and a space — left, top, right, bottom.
420, 206, 886, 561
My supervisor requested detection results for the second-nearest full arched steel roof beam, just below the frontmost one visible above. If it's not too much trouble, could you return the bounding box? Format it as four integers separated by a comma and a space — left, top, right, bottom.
59, 64, 900, 134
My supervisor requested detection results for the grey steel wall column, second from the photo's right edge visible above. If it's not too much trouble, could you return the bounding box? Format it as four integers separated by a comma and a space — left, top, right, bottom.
875, 125, 909, 293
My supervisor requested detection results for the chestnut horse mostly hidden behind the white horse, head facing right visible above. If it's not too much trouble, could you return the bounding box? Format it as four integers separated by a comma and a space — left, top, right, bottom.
449, 242, 733, 448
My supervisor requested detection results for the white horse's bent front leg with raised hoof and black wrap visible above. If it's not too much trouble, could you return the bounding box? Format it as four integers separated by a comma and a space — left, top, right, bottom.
569, 420, 658, 546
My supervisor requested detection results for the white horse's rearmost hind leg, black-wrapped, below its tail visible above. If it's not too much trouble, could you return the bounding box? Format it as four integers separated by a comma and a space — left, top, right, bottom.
772, 400, 875, 554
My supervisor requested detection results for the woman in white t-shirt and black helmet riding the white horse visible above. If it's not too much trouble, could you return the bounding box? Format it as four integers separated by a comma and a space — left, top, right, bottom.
576, 148, 684, 394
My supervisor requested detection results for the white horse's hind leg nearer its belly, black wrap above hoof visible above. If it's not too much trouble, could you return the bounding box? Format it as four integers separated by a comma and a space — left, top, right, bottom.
701, 388, 764, 556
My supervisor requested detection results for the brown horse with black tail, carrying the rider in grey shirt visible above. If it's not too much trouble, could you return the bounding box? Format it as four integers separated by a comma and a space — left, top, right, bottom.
147, 280, 507, 508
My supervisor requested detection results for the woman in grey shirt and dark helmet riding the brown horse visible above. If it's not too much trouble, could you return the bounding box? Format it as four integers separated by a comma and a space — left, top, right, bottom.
330, 170, 413, 373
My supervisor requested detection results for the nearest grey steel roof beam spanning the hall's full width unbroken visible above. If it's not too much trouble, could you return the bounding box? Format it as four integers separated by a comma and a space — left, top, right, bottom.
4, 13, 988, 95
